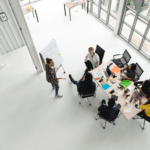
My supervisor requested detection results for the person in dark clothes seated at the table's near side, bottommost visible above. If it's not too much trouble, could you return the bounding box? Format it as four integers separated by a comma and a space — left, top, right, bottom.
98, 98, 121, 121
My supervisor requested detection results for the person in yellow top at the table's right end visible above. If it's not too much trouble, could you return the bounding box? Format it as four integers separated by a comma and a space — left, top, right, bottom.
135, 100, 150, 118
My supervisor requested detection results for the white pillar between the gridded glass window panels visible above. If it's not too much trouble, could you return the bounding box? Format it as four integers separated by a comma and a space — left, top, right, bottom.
114, 0, 126, 35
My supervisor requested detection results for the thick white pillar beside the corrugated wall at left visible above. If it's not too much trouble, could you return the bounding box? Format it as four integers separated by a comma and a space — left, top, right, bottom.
8, 0, 43, 72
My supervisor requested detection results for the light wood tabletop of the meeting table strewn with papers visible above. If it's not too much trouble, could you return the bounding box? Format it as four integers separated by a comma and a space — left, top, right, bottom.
90, 61, 148, 120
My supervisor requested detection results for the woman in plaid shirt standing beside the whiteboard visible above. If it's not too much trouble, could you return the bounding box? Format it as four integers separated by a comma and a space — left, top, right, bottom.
45, 58, 65, 98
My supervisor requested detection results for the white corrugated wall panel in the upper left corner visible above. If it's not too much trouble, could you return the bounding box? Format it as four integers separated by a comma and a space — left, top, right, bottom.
0, 0, 25, 54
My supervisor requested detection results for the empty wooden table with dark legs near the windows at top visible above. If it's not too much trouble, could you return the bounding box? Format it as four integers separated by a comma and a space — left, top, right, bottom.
64, 0, 89, 21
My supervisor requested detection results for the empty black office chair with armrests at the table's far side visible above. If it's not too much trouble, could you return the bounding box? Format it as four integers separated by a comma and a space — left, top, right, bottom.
112, 50, 131, 68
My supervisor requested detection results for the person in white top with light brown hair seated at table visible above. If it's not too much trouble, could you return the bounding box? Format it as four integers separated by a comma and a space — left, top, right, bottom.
85, 47, 99, 68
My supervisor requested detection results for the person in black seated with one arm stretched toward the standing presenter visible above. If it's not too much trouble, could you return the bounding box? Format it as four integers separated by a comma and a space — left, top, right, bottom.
69, 73, 96, 95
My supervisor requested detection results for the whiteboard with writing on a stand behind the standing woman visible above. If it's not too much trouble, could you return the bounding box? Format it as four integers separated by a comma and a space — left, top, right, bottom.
40, 39, 63, 67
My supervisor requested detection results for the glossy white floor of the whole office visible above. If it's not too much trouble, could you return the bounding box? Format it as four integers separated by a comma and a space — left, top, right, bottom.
0, 0, 150, 150
